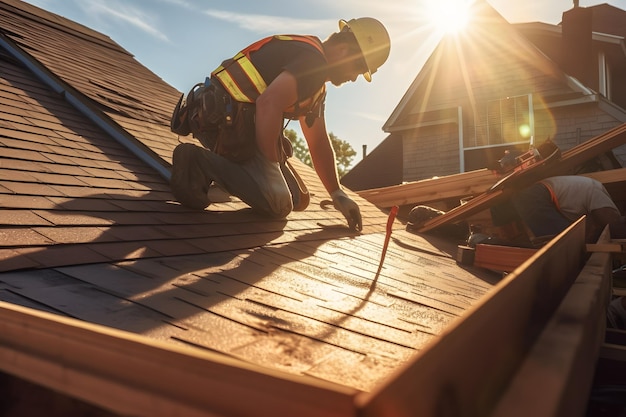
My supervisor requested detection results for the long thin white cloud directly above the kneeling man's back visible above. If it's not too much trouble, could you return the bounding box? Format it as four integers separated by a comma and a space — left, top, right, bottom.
204, 9, 336, 33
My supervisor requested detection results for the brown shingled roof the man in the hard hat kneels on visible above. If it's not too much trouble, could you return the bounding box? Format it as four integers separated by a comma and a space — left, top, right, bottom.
0, 0, 494, 390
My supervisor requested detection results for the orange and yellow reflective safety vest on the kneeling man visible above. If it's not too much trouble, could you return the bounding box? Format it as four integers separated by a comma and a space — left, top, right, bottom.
211, 35, 326, 119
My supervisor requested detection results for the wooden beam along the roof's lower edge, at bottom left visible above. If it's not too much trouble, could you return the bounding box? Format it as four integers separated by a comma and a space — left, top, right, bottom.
0, 302, 357, 417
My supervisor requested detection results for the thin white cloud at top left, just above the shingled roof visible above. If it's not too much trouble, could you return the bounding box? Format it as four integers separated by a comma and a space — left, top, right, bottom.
78, 0, 169, 42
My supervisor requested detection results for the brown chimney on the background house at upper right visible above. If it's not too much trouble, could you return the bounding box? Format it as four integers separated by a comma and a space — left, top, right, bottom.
561, 4, 598, 89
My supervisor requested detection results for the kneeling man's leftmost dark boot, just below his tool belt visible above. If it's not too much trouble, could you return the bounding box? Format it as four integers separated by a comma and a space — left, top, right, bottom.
170, 143, 212, 210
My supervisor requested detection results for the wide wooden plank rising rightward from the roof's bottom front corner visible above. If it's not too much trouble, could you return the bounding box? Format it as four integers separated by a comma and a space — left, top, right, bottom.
357, 220, 585, 417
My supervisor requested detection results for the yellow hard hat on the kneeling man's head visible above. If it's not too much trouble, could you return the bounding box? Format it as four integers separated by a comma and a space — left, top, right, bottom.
339, 17, 391, 81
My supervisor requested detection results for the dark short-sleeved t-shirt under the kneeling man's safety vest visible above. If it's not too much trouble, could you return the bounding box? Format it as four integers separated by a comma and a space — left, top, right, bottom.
250, 40, 328, 101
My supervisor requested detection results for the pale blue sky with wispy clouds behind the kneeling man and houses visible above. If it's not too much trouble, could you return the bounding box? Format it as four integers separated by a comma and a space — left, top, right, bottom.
22, 0, 626, 159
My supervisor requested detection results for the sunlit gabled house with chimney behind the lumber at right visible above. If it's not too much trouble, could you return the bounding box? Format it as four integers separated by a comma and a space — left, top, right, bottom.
342, 1, 626, 190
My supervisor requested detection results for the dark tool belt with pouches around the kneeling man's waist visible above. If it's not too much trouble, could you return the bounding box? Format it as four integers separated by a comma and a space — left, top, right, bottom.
170, 78, 257, 162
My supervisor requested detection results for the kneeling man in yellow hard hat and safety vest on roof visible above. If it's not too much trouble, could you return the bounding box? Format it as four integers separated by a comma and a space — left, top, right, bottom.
166, 18, 390, 230
